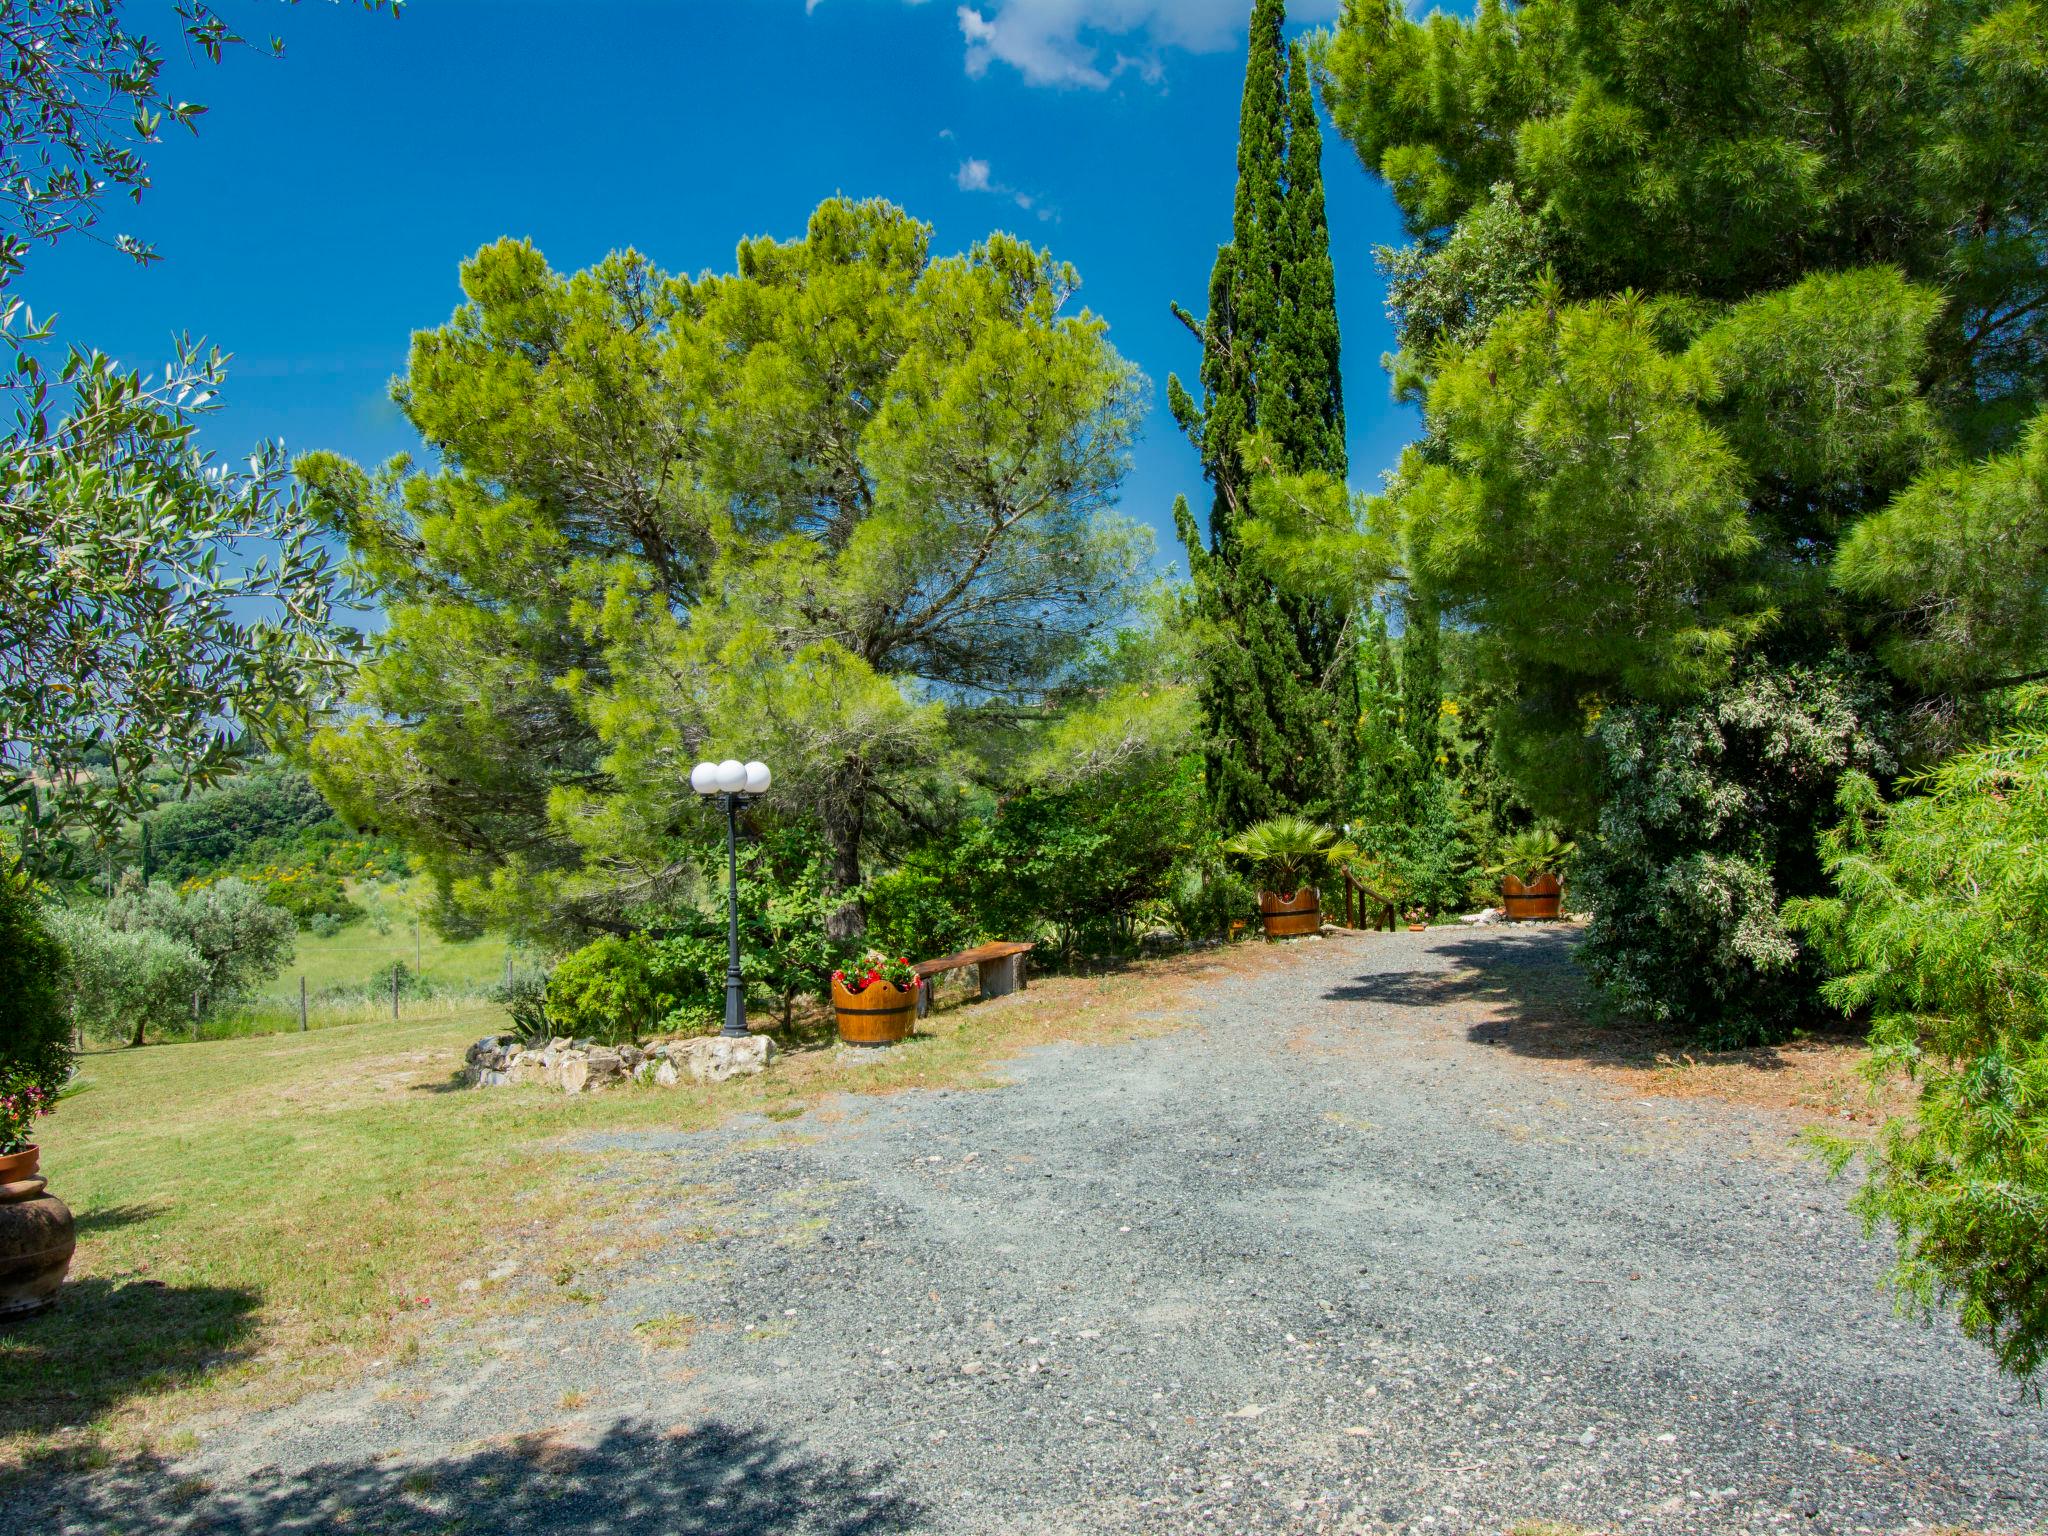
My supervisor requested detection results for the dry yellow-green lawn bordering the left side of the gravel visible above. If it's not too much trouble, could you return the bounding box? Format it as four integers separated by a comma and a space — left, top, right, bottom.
0, 946, 1268, 1468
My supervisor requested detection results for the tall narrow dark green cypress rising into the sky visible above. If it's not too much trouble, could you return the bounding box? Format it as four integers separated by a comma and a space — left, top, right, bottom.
1167, 0, 1358, 827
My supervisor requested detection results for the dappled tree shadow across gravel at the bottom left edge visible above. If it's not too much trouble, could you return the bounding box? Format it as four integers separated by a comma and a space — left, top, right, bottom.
18, 1421, 926, 1536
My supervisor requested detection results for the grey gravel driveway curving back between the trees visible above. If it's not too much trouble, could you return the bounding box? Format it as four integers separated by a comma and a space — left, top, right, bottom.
19, 930, 2048, 1536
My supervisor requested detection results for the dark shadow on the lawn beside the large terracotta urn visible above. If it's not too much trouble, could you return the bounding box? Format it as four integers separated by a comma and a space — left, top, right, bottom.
0, 1277, 258, 1434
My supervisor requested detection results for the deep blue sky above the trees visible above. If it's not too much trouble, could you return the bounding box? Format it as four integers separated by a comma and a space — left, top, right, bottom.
39, 0, 1415, 565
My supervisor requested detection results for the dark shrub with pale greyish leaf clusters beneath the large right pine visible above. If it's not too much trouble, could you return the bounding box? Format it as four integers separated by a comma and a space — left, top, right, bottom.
1573, 662, 1892, 1047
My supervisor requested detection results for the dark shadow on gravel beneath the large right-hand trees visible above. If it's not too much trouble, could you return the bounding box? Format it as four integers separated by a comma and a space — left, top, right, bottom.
1325, 926, 1860, 1071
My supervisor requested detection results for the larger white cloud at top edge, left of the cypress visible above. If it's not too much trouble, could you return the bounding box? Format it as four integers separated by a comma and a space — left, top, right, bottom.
958, 0, 1337, 90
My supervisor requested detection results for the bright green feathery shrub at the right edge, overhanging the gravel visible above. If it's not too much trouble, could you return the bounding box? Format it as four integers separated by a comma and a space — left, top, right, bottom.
1792, 694, 2048, 1378
